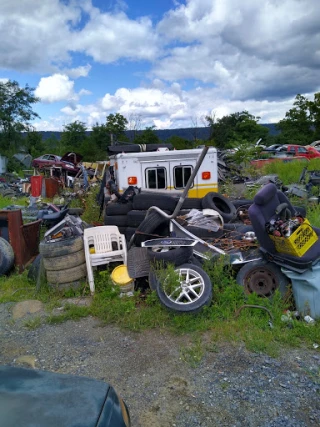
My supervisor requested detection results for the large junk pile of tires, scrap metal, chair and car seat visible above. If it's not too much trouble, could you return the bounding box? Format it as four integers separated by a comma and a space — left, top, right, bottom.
0, 145, 320, 317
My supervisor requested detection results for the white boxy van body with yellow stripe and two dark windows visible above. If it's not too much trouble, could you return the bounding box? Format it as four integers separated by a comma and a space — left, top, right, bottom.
110, 147, 218, 198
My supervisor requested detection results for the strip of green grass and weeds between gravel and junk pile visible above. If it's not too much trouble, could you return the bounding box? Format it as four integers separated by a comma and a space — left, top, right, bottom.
0, 252, 320, 360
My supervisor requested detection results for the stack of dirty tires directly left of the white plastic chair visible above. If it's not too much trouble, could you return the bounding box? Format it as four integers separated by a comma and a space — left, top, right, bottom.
39, 236, 87, 288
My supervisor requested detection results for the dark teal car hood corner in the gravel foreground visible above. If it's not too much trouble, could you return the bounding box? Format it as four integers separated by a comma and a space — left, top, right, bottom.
0, 366, 131, 427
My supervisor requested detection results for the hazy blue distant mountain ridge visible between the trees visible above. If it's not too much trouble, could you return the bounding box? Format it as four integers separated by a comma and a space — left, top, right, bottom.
40, 123, 279, 141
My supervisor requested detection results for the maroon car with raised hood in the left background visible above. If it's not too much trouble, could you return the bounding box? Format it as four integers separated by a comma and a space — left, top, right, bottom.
31, 152, 82, 175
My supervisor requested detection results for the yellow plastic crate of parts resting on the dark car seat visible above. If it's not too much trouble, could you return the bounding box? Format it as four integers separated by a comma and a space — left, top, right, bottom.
270, 219, 318, 257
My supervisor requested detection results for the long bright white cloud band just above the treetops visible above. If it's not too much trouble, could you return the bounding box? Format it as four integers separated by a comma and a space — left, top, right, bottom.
40, 85, 294, 129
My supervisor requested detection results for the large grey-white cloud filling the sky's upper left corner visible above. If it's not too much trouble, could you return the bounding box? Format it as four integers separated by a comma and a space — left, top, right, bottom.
0, 0, 158, 72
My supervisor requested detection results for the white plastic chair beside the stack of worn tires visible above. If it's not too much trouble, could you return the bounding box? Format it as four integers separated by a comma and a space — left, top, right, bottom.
83, 225, 127, 294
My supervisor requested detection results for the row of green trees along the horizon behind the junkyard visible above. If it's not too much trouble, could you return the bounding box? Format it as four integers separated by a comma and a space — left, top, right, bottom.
0, 80, 320, 170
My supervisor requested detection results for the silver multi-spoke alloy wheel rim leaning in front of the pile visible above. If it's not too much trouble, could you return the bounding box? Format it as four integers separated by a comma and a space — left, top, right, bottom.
163, 268, 205, 305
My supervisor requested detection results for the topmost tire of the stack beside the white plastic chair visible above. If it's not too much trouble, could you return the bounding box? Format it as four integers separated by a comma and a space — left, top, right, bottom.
39, 236, 84, 258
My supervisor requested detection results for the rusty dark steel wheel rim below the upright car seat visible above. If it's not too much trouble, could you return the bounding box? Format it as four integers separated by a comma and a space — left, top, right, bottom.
244, 267, 278, 297
